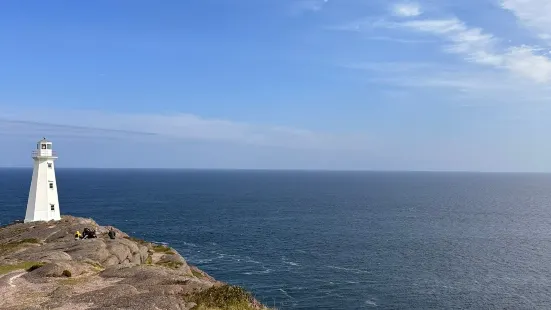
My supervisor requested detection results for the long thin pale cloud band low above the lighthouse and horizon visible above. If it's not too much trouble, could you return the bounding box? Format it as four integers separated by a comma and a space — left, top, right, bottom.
0, 106, 369, 150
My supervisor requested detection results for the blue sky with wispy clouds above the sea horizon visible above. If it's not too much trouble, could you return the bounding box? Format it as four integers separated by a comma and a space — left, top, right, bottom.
0, 0, 551, 171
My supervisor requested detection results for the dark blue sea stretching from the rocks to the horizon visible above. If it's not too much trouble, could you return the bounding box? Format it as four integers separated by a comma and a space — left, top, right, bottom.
0, 169, 551, 309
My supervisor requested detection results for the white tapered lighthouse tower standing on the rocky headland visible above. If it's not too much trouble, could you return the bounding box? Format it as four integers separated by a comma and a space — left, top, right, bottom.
25, 138, 61, 223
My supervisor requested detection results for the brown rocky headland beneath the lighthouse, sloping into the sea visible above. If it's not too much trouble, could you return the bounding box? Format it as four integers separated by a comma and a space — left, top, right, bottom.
0, 216, 266, 310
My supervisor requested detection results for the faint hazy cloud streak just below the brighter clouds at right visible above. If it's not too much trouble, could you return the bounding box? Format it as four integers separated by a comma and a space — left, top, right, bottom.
360, 63, 551, 106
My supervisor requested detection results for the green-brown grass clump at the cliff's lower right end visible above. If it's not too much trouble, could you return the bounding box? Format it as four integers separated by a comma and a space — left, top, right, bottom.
185, 285, 255, 310
